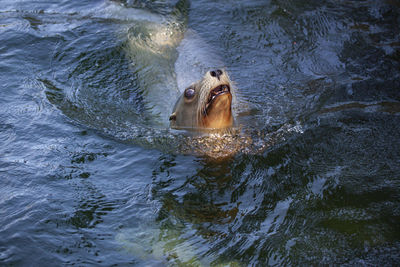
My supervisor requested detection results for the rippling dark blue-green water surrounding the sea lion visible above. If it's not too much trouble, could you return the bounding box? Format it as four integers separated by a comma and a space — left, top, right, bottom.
0, 0, 400, 266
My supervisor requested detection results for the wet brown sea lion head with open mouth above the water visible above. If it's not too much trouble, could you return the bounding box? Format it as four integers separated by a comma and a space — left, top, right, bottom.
169, 69, 233, 129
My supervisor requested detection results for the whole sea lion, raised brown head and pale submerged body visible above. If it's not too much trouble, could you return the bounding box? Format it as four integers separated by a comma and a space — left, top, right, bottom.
122, 0, 233, 129
